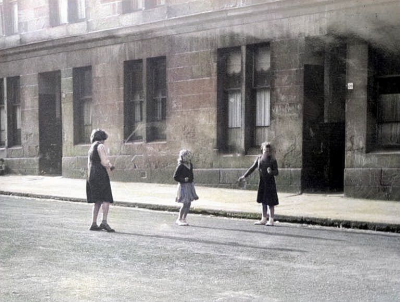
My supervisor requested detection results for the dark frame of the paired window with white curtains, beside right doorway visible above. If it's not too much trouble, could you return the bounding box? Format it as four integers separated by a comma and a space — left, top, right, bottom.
217, 42, 272, 154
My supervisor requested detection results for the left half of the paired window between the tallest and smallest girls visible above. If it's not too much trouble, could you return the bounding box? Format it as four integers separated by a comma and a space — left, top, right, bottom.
124, 60, 145, 141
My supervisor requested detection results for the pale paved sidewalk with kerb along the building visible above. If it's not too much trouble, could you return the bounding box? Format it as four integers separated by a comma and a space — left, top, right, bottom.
0, 175, 400, 233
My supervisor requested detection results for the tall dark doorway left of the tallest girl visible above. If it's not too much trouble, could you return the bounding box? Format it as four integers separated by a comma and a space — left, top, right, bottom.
39, 71, 62, 175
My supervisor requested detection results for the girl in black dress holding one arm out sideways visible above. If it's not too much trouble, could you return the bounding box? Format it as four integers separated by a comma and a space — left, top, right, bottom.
239, 142, 279, 226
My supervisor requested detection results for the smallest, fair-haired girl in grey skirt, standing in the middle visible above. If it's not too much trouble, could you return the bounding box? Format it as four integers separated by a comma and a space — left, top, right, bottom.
174, 150, 199, 226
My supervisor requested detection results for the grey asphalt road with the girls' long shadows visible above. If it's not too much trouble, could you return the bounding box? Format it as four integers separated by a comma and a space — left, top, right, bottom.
0, 196, 400, 302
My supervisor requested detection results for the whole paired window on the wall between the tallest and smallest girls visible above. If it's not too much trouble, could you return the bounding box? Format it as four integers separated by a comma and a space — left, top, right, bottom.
124, 57, 167, 141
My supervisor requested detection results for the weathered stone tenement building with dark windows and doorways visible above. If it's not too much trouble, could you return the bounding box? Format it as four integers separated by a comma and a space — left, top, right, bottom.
0, 0, 400, 200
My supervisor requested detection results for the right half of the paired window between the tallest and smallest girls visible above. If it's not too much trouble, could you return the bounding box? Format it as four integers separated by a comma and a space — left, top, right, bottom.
147, 58, 167, 141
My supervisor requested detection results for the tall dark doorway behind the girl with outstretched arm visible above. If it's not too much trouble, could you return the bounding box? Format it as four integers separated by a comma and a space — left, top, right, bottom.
302, 41, 346, 192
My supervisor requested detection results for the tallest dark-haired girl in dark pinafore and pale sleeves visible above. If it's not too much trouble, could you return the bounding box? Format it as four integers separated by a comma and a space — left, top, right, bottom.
86, 129, 115, 232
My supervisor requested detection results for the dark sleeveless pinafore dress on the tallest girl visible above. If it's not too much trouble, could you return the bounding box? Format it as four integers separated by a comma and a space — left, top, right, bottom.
86, 142, 114, 203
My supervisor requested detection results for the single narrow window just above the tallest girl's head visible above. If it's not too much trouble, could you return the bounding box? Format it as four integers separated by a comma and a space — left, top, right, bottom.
73, 66, 92, 144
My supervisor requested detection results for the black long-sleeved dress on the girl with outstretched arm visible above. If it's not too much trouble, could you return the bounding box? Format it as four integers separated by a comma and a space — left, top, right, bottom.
244, 155, 279, 206
